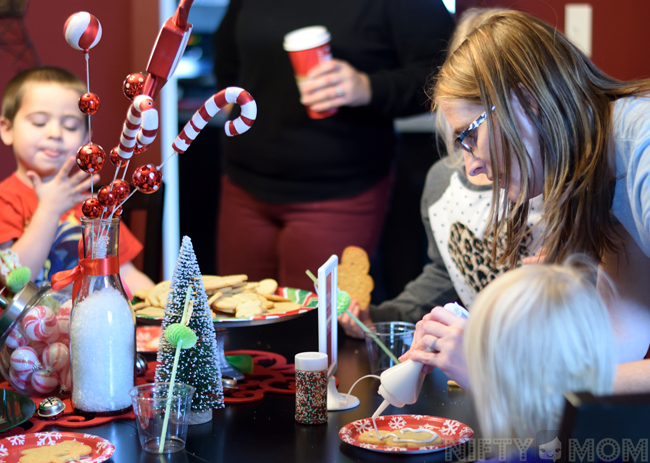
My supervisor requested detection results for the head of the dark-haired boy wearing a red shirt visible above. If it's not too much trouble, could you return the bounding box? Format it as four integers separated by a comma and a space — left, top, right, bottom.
0, 66, 87, 180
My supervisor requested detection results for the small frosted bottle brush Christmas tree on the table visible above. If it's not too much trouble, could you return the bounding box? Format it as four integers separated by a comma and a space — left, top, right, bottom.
155, 236, 224, 424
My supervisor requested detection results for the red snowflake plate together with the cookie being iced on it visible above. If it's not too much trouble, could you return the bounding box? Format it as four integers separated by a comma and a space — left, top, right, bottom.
339, 415, 474, 455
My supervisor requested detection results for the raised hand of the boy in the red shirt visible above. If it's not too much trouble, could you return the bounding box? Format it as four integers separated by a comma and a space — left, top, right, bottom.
26, 157, 99, 218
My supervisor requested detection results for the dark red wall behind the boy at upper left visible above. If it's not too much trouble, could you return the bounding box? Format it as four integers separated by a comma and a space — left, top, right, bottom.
0, 0, 160, 182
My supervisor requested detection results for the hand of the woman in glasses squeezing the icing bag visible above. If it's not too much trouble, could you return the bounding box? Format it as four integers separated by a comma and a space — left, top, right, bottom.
400, 307, 469, 389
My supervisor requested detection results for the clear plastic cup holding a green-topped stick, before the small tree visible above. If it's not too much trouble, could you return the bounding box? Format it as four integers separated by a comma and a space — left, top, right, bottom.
129, 383, 195, 453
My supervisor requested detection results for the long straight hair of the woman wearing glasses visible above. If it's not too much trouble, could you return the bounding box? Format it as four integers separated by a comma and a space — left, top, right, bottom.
432, 10, 650, 267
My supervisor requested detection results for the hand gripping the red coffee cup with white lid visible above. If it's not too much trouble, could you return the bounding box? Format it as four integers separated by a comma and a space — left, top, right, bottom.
298, 59, 372, 112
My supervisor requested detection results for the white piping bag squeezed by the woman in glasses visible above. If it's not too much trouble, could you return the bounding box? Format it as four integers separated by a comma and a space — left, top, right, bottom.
372, 302, 469, 422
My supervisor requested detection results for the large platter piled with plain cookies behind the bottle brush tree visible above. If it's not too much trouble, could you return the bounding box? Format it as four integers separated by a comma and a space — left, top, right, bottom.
133, 275, 318, 325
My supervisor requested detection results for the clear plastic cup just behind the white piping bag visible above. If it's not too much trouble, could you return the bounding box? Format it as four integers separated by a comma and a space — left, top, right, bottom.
365, 322, 415, 375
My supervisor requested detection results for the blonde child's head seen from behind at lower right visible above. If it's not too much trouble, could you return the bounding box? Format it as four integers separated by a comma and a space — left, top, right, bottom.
464, 257, 614, 438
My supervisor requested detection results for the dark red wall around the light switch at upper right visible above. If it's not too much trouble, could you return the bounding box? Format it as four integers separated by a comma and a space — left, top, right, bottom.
457, 0, 650, 80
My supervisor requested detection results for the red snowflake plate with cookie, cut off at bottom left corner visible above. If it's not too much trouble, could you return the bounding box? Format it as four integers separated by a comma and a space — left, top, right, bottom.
0, 432, 115, 463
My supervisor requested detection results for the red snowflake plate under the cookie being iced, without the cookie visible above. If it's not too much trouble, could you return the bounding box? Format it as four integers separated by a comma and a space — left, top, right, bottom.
339, 415, 474, 455
